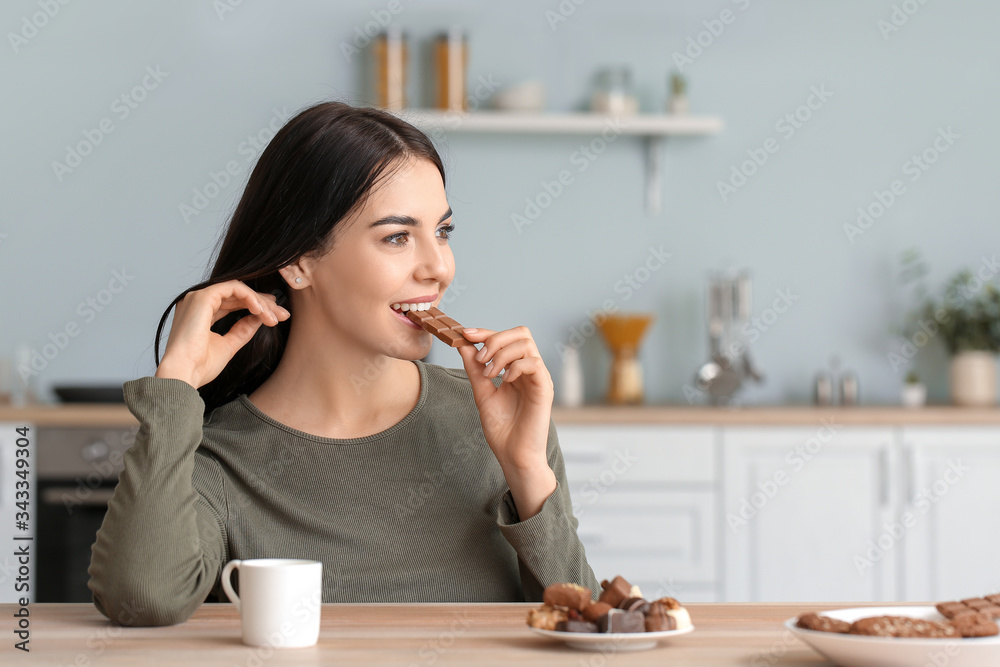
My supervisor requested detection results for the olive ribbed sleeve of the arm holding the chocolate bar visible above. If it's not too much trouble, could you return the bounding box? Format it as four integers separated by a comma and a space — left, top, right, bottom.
497, 419, 601, 602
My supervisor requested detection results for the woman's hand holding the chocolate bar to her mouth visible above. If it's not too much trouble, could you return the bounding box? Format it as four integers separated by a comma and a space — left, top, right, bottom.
458, 326, 554, 472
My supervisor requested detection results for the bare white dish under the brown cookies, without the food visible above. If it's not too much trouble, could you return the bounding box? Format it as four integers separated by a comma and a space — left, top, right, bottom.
785, 607, 1000, 667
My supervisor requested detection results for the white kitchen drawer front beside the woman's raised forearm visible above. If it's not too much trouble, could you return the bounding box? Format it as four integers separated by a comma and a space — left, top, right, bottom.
558, 425, 719, 601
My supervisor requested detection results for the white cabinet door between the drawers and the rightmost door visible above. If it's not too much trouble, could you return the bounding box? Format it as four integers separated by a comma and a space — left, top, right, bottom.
719, 425, 901, 601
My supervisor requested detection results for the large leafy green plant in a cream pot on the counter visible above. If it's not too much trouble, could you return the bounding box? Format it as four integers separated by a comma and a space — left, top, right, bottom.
909, 265, 1000, 406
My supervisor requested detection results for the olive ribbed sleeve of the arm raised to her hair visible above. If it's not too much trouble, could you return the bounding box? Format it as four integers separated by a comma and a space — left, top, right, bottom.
87, 377, 227, 626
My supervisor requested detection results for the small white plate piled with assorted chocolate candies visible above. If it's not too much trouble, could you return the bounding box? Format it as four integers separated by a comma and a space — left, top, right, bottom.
528, 576, 694, 653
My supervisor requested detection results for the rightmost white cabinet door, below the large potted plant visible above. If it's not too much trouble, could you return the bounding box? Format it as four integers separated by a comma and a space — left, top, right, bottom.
900, 426, 1000, 601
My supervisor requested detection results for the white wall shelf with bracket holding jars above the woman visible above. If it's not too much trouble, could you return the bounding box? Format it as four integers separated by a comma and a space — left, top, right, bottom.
398, 109, 723, 214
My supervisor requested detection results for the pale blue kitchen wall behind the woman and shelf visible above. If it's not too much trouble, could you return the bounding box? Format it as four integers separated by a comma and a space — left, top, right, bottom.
0, 0, 1000, 403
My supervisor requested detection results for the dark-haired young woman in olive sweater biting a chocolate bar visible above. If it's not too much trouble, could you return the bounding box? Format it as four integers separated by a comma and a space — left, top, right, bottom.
89, 102, 600, 625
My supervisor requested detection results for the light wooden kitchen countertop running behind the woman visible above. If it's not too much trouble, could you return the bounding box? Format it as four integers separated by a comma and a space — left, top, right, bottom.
0, 403, 1000, 427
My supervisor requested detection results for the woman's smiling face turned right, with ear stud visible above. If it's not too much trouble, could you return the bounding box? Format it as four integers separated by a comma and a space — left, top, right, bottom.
291, 159, 455, 359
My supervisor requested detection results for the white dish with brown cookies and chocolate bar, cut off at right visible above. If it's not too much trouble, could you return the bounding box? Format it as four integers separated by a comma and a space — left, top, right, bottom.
785, 595, 1000, 667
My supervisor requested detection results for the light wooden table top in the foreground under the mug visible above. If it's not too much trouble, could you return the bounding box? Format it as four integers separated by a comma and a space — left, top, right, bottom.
0, 602, 926, 667
